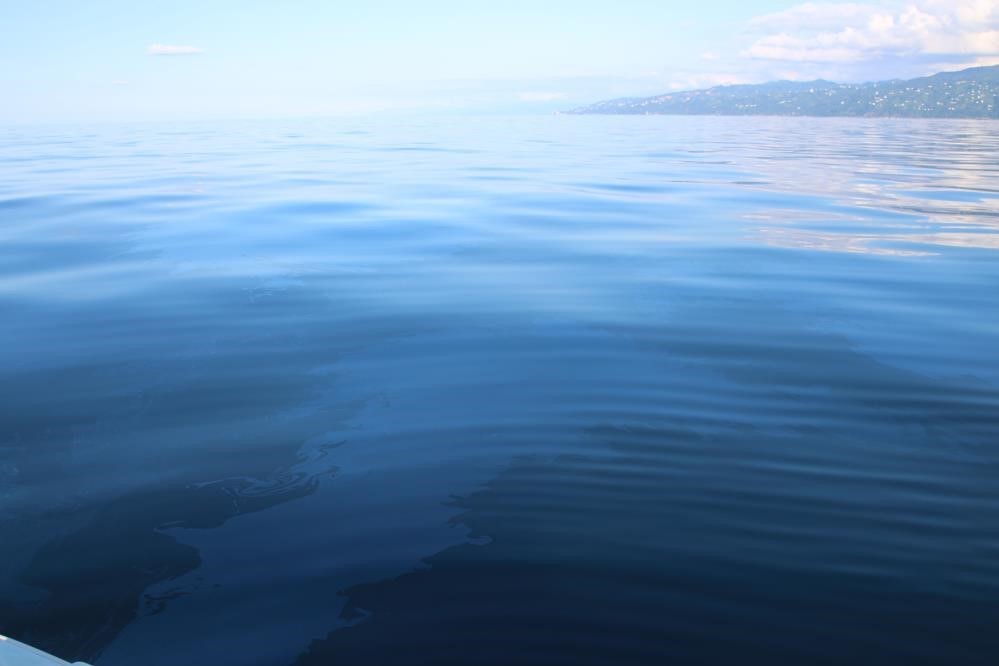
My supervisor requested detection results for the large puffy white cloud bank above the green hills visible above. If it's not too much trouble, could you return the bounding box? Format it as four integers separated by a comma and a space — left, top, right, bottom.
743, 0, 999, 63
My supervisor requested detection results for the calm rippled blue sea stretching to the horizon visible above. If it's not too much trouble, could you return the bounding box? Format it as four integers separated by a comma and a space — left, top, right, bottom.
0, 117, 999, 666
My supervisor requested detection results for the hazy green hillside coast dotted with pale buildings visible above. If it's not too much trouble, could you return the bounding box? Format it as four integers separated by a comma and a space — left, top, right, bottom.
565, 65, 999, 119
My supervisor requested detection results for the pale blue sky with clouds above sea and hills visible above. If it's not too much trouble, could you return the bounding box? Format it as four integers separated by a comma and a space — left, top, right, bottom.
0, 0, 999, 123
